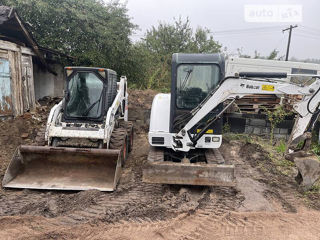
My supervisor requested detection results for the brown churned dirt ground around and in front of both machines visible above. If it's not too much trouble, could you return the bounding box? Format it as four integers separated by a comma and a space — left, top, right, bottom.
0, 91, 320, 240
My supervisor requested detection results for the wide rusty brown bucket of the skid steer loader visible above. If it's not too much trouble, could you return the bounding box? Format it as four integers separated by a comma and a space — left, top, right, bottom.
2, 146, 122, 191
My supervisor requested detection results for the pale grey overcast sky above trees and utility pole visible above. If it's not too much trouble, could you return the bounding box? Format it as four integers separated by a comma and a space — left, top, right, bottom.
123, 0, 320, 59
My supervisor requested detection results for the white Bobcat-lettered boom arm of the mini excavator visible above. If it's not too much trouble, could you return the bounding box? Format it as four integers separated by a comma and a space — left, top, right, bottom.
172, 72, 320, 152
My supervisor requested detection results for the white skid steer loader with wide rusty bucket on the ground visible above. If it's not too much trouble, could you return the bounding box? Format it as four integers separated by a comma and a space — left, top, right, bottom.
2, 67, 133, 191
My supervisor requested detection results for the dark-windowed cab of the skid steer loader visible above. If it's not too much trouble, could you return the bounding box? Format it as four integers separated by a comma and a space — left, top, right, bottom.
63, 67, 117, 123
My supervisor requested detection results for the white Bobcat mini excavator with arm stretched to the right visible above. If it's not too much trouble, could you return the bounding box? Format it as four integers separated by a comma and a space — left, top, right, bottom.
143, 54, 320, 186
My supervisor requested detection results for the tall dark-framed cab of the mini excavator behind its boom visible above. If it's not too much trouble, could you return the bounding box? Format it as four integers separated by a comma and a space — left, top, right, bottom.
170, 53, 225, 134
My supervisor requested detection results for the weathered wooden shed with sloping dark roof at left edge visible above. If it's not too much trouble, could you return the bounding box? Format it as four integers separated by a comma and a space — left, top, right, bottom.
0, 6, 70, 117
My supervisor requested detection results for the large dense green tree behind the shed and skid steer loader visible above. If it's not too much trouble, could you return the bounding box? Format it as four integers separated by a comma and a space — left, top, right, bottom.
3, 0, 136, 74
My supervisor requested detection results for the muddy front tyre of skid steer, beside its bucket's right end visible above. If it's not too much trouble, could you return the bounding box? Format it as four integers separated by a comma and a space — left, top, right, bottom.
109, 128, 128, 166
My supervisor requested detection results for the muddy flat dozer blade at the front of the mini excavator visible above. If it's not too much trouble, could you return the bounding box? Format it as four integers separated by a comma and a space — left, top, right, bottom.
143, 148, 236, 187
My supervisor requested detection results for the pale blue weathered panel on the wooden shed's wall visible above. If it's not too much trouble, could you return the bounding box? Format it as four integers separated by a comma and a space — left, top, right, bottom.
0, 58, 12, 116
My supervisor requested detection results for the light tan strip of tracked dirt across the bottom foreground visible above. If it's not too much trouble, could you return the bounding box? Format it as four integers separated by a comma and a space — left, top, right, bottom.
36, 205, 320, 240
